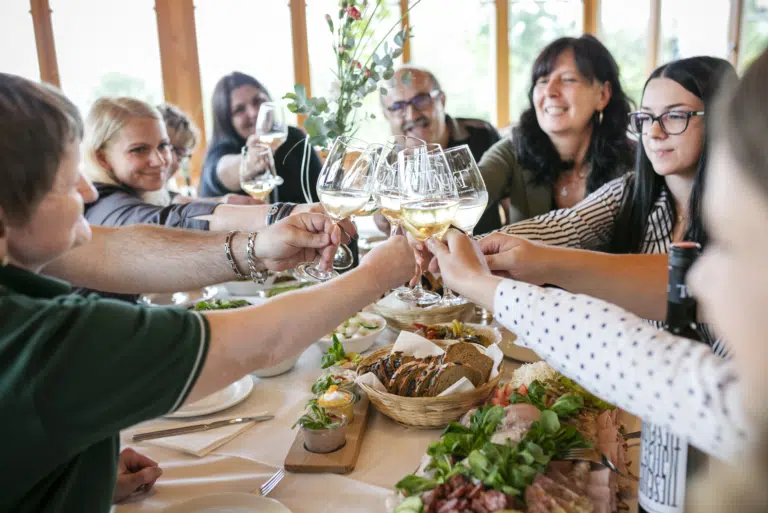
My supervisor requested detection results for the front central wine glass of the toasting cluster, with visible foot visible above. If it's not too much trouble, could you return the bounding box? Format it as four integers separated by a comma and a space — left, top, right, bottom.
397, 145, 459, 305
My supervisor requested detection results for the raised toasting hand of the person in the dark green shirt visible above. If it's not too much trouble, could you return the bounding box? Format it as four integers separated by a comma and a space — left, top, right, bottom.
360, 235, 416, 289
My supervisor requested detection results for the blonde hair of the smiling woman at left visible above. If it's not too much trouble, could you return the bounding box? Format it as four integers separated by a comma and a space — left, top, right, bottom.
83, 97, 170, 206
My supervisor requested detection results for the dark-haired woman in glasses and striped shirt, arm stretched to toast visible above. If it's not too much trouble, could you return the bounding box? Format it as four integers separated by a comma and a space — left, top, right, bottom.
474, 57, 736, 328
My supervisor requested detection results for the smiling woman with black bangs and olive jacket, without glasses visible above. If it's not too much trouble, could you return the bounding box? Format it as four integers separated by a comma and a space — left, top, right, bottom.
479, 35, 634, 223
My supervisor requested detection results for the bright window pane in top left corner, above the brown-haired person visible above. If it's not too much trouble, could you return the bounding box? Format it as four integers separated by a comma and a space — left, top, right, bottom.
0, 1, 40, 80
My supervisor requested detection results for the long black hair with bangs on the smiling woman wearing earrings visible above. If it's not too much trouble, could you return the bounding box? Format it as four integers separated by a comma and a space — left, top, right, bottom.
512, 35, 634, 192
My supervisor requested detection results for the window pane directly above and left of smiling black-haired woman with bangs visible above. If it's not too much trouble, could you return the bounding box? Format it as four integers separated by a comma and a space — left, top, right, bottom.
509, 0, 583, 124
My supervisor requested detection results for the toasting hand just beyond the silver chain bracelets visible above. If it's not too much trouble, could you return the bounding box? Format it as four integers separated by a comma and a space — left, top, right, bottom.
254, 213, 350, 271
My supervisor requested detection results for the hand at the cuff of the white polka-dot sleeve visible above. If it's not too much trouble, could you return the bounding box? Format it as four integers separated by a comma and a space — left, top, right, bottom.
426, 228, 500, 308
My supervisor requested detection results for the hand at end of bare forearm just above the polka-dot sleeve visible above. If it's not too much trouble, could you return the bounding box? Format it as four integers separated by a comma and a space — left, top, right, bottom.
480, 233, 557, 285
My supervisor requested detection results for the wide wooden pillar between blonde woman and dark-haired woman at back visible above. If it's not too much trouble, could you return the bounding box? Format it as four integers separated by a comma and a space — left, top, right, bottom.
155, 0, 206, 185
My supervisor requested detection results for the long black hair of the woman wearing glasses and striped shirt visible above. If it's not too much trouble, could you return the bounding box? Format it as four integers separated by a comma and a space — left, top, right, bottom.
611, 57, 736, 253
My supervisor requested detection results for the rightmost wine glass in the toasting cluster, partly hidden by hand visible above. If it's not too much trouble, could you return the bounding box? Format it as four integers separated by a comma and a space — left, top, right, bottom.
442, 144, 488, 306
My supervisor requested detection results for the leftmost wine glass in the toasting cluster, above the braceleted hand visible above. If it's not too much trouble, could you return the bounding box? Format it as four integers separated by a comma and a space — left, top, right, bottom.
296, 137, 380, 281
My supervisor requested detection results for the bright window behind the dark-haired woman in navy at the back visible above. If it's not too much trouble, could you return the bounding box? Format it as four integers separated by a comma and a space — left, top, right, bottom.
195, 0, 296, 134
